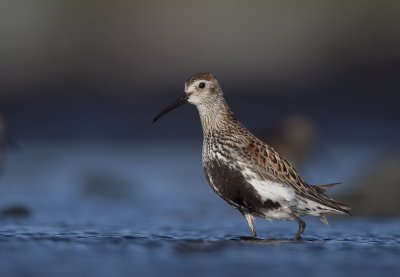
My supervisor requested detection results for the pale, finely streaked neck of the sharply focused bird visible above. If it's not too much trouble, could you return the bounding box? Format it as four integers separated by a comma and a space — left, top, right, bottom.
197, 97, 236, 134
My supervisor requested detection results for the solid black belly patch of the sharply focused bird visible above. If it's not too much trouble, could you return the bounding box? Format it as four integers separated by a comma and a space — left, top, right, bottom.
204, 161, 281, 215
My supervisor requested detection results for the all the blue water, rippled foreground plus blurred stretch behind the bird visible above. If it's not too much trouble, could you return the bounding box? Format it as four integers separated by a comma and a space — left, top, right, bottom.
0, 143, 400, 276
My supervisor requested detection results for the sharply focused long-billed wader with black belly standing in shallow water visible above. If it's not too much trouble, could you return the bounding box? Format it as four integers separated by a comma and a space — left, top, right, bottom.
153, 73, 351, 239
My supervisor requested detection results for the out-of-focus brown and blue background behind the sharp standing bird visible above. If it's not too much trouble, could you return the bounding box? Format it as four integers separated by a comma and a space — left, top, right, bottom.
0, 0, 400, 276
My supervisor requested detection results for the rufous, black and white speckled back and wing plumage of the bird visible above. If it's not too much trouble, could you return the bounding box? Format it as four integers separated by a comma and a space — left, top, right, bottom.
203, 114, 348, 216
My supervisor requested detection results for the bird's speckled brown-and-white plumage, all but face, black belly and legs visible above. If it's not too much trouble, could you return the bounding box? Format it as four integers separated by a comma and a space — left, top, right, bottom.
186, 73, 350, 219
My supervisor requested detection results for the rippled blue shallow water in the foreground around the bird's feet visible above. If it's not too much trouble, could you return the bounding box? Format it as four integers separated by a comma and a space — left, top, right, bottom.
0, 219, 400, 276
